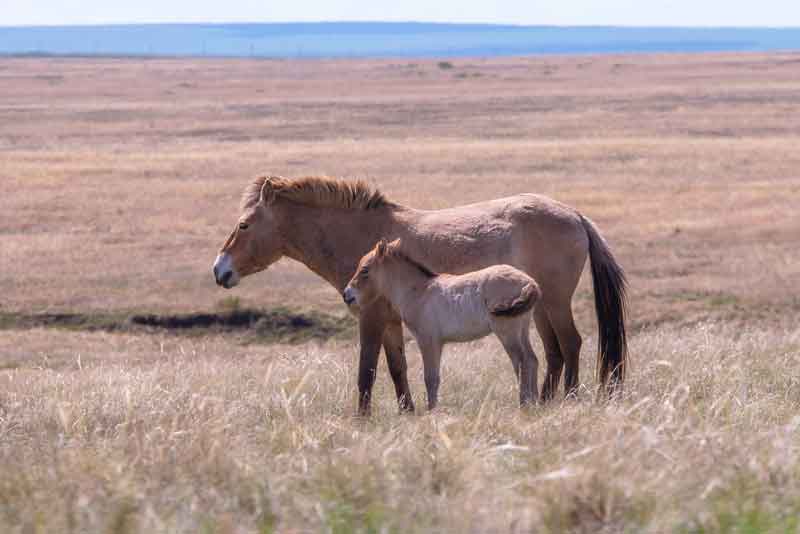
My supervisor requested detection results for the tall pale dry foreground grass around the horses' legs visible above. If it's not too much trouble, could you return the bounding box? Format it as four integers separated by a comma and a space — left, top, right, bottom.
0, 323, 800, 532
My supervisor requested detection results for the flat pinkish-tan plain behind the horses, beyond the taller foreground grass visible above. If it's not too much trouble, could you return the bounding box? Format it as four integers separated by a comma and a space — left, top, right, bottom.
0, 54, 800, 322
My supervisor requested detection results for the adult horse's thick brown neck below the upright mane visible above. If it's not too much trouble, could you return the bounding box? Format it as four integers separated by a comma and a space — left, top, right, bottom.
281, 204, 396, 291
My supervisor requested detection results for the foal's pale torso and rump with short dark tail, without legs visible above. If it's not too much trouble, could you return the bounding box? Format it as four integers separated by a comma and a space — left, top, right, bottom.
421, 265, 539, 342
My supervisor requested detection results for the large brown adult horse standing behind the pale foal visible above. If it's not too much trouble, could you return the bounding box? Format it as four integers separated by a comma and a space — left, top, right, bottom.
214, 176, 627, 414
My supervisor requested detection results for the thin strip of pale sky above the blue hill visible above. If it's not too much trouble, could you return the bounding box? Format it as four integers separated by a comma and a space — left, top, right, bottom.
0, 0, 800, 26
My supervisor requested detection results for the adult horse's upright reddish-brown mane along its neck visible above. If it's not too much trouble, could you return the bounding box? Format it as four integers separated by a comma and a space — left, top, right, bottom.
241, 176, 395, 210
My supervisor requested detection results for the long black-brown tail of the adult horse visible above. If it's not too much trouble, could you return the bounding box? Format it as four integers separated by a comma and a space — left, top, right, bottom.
581, 215, 628, 394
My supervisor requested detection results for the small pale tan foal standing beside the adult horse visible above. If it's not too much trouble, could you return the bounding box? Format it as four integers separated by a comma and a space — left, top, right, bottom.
343, 239, 540, 410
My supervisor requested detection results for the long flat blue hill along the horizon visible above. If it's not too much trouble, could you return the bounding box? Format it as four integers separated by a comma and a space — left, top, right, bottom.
0, 22, 800, 58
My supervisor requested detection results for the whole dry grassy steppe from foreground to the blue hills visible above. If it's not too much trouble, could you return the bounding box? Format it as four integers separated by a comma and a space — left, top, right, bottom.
0, 53, 800, 533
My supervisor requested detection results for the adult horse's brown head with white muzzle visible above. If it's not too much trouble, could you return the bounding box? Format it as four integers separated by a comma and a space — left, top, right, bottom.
214, 179, 283, 289
